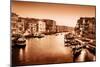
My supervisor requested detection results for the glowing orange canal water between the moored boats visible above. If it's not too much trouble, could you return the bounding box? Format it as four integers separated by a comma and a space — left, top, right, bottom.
12, 34, 95, 65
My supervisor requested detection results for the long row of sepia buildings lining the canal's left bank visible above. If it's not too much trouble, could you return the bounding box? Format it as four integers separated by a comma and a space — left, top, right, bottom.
11, 13, 76, 35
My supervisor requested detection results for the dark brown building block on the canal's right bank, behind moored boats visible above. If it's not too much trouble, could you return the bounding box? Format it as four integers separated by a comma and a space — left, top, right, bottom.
75, 17, 96, 38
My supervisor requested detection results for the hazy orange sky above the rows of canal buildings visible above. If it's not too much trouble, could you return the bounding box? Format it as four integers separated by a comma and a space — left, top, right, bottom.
12, 1, 96, 27
